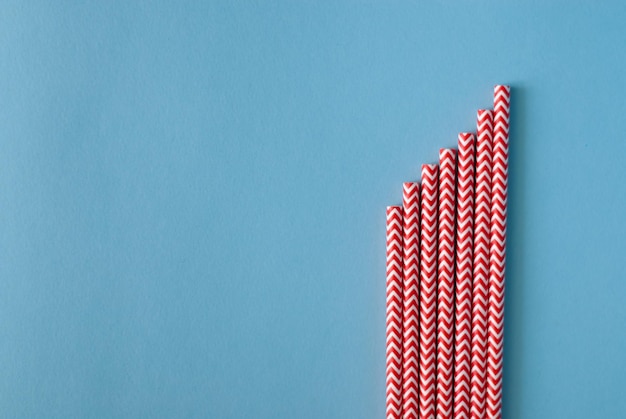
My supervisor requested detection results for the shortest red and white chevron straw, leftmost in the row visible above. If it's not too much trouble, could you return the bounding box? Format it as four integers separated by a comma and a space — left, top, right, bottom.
386, 206, 402, 419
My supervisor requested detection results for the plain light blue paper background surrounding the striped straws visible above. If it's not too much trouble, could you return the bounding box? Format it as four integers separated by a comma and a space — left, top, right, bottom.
0, 1, 626, 418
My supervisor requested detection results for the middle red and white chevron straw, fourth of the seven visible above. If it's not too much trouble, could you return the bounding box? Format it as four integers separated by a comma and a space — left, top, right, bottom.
436, 148, 456, 419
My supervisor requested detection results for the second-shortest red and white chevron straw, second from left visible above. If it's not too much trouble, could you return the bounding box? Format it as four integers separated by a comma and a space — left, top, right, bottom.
402, 182, 419, 419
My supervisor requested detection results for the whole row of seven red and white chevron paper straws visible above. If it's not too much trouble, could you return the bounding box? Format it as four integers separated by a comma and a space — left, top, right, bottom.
386, 85, 510, 419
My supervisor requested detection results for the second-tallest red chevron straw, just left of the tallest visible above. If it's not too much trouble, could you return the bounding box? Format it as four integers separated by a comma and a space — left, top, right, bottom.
470, 110, 493, 419
